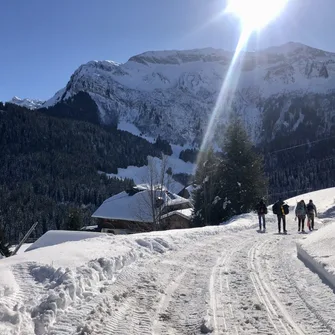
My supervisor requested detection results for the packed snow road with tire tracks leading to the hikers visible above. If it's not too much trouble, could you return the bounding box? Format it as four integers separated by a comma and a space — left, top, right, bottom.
50, 219, 335, 334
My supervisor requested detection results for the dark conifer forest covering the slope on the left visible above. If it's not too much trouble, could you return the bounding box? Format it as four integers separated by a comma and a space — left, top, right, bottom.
0, 103, 169, 243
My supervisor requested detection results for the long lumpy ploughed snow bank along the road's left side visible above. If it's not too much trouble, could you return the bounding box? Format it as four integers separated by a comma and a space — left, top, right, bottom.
0, 214, 255, 335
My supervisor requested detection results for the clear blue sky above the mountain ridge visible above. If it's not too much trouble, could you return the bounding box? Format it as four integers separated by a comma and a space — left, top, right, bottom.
0, 0, 335, 101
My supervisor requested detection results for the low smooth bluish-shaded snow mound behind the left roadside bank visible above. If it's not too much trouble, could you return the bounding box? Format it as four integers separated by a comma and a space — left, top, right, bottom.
26, 230, 101, 251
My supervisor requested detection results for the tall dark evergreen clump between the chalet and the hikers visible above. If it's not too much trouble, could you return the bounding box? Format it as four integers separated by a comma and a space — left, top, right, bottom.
192, 119, 266, 227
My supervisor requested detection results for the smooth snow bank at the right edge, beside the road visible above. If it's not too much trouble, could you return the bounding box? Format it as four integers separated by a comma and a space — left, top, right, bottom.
297, 221, 335, 290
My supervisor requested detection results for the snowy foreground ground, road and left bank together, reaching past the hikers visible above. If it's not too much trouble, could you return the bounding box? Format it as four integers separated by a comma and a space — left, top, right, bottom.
0, 189, 335, 335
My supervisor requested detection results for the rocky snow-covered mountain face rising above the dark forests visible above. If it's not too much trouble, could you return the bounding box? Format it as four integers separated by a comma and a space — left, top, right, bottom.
44, 43, 335, 144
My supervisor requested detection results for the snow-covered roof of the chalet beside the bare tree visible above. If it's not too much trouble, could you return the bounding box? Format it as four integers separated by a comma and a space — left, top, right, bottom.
92, 184, 191, 222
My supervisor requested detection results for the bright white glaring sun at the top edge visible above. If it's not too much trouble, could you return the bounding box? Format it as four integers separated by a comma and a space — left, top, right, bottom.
225, 0, 289, 32
